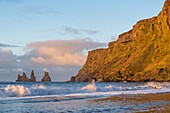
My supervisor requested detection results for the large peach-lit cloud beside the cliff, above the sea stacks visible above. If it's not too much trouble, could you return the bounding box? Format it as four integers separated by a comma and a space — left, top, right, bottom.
25, 39, 106, 66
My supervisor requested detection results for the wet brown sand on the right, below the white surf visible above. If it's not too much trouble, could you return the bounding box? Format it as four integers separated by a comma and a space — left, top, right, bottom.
92, 93, 170, 113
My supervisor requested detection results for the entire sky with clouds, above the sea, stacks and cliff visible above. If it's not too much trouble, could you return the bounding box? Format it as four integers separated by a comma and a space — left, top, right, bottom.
0, 0, 164, 81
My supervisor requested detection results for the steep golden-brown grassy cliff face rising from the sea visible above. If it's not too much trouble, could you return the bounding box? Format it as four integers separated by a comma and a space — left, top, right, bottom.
74, 0, 170, 82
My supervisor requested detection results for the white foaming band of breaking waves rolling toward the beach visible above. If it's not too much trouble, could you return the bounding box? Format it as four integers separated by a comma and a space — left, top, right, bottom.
0, 82, 170, 99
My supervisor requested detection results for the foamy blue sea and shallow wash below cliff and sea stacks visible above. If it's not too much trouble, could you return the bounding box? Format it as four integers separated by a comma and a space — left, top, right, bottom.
0, 82, 170, 113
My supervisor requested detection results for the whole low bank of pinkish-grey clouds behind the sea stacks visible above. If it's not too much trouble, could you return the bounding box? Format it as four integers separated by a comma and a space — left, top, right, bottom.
0, 39, 106, 81
